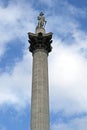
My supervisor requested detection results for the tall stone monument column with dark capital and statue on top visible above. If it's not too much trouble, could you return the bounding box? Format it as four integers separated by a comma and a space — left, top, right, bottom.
28, 12, 52, 130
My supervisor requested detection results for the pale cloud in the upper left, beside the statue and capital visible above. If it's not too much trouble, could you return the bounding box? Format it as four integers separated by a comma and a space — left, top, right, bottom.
0, 1, 36, 56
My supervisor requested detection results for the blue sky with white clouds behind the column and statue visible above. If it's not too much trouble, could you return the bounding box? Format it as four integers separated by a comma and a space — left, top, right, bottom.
0, 0, 87, 130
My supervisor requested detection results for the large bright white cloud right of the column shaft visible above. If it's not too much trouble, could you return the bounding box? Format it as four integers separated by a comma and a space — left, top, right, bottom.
49, 35, 87, 114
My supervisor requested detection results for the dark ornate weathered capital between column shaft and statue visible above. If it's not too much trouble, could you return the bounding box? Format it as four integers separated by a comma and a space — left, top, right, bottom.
28, 32, 52, 53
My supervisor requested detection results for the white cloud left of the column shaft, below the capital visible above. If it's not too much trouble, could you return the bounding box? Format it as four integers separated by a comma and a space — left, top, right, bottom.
0, 53, 32, 109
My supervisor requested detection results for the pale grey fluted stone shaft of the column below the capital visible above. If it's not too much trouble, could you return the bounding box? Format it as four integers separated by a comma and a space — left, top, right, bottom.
30, 49, 50, 130
